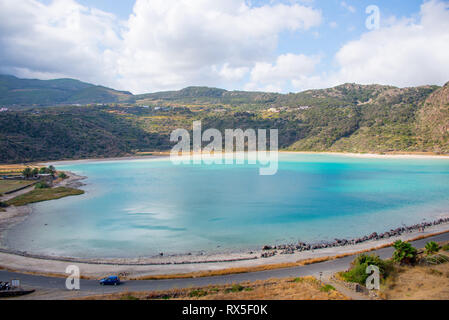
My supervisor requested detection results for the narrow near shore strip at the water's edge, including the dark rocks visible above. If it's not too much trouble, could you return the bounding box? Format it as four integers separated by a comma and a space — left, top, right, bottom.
0, 216, 449, 267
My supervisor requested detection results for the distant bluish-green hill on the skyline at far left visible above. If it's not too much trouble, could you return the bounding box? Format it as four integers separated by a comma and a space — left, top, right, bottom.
0, 75, 133, 106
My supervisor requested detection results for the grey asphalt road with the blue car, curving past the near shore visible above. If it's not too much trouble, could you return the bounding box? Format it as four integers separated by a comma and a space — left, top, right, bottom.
0, 233, 449, 294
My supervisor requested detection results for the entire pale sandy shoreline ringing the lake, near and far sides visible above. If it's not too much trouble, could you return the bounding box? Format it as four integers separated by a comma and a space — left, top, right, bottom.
0, 158, 449, 276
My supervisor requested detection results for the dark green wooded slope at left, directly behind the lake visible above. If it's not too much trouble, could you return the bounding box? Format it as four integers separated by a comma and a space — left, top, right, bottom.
0, 107, 170, 163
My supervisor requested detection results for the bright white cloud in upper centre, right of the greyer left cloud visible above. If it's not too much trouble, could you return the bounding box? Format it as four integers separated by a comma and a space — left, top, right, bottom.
114, 0, 321, 91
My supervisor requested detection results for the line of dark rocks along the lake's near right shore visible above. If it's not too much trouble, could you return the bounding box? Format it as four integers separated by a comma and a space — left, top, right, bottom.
261, 217, 449, 258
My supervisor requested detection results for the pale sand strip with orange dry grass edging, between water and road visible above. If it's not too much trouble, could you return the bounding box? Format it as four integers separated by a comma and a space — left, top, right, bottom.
0, 223, 449, 279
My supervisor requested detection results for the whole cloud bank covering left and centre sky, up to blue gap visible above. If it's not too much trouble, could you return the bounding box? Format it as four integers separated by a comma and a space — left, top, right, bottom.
0, 0, 322, 92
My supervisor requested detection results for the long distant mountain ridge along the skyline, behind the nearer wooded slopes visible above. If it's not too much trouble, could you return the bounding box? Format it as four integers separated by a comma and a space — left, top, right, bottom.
0, 75, 439, 107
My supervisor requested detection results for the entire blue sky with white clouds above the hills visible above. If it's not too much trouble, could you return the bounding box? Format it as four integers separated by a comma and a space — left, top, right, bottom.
0, 0, 449, 94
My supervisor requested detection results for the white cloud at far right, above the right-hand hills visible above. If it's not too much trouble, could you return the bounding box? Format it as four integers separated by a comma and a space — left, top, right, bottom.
327, 0, 449, 87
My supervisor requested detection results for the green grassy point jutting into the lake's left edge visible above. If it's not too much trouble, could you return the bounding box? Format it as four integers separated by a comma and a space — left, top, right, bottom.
6, 187, 84, 207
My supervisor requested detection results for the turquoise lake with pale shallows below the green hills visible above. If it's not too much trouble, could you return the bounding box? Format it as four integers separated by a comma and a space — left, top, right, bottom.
5, 154, 449, 258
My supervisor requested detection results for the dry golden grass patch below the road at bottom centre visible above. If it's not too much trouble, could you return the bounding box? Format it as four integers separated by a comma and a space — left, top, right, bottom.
79, 277, 349, 301
